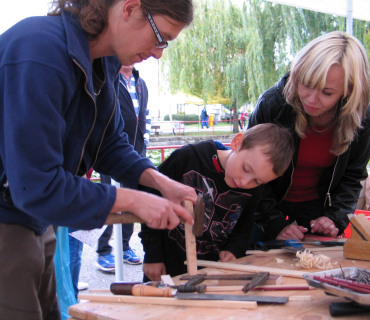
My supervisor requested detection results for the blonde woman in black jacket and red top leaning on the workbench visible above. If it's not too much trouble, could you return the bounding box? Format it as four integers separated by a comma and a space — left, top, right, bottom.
249, 31, 370, 243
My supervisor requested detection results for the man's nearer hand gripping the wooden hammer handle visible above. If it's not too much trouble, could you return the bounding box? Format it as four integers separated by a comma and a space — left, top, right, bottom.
108, 188, 194, 230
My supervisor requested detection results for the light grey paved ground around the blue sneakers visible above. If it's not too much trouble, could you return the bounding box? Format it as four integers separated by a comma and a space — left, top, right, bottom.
80, 224, 144, 292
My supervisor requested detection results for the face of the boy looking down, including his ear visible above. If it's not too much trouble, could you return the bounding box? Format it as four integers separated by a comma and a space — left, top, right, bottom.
224, 134, 278, 189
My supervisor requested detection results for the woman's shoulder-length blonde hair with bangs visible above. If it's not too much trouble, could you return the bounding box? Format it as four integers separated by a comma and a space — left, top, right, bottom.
283, 31, 370, 155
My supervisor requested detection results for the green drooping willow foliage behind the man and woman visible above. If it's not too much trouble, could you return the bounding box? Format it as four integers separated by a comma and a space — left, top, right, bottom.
163, 0, 370, 106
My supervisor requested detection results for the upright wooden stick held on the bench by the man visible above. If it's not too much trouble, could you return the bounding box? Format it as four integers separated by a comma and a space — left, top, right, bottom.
185, 200, 198, 276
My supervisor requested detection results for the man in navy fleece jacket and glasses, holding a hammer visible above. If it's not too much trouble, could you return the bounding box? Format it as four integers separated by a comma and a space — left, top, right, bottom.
0, 0, 196, 320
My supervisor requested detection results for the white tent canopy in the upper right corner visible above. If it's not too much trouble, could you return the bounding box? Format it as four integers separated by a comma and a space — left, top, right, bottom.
267, 0, 370, 34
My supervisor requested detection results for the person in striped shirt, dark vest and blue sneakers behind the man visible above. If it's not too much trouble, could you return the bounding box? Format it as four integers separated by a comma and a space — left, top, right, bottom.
96, 64, 151, 272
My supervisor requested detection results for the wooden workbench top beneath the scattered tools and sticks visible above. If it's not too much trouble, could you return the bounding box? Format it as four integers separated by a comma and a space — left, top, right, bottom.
69, 250, 370, 320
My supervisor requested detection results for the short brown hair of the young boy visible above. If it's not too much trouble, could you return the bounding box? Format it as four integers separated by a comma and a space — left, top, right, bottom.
240, 123, 294, 176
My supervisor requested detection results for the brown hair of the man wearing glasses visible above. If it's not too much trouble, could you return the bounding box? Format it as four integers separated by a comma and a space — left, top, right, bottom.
49, 0, 194, 40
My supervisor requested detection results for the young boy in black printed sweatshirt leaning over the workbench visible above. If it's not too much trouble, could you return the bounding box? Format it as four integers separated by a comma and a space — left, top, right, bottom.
139, 123, 294, 281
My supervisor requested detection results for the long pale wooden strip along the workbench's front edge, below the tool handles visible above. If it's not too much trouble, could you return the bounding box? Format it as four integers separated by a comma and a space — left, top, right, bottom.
78, 294, 257, 310
